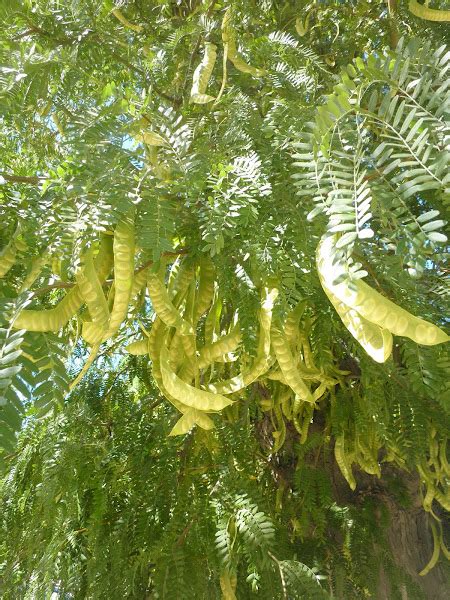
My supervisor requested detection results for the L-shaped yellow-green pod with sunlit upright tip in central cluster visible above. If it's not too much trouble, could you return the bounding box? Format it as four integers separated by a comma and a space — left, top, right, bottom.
205, 287, 278, 394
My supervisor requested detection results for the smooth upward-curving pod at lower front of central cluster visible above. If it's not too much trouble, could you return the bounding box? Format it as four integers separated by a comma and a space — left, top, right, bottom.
160, 346, 232, 412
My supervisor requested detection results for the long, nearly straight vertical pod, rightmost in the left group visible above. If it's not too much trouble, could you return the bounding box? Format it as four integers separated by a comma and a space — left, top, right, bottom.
103, 215, 135, 341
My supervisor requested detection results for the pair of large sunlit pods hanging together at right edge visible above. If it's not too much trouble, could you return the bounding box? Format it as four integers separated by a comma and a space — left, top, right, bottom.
316, 235, 448, 363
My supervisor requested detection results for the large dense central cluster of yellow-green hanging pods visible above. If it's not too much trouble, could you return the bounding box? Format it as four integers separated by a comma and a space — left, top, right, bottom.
134, 257, 339, 436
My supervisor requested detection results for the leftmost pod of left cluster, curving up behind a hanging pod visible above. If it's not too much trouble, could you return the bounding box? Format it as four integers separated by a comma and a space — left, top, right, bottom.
12, 236, 112, 331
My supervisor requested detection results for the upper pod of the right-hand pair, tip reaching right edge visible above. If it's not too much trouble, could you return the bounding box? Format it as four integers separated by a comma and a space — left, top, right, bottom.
317, 236, 449, 346
